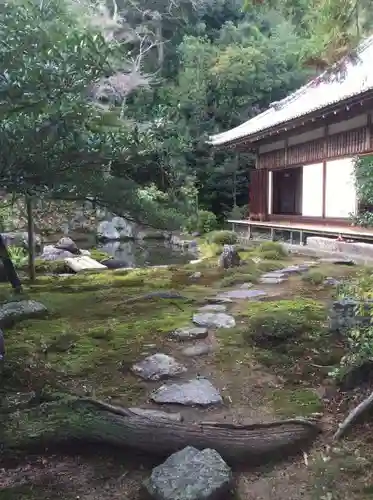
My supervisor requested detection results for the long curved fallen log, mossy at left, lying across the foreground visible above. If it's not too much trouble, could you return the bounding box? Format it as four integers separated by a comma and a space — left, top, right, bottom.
2, 399, 321, 463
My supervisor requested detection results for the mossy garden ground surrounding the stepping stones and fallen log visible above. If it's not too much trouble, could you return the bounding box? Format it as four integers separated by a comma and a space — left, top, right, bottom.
0, 243, 373, 500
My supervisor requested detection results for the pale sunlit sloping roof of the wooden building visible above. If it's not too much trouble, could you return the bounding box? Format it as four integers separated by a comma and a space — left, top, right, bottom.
209, 36, 373, 146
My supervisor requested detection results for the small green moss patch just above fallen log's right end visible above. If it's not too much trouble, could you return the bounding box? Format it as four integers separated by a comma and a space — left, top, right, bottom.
270, 389, 323, 417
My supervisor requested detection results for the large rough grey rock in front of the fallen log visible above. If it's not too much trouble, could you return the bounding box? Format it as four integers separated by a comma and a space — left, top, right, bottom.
144, 446, 232, 500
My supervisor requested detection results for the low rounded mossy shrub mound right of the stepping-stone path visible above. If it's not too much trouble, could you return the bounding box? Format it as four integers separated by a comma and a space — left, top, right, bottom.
243, 299, 325, 347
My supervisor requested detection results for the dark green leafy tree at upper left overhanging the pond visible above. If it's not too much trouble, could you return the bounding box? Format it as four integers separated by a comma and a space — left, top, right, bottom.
0, 0, 185, 229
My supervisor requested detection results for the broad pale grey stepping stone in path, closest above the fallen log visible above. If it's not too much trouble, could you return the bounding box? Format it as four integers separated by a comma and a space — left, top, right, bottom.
150, 378, 223, 406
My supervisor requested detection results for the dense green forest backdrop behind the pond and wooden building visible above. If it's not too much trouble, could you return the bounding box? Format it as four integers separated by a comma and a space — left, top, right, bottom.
0, 0, 373, 227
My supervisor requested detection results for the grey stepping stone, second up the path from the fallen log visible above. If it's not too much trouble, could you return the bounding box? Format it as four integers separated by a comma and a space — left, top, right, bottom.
132, 353, 187, 380
